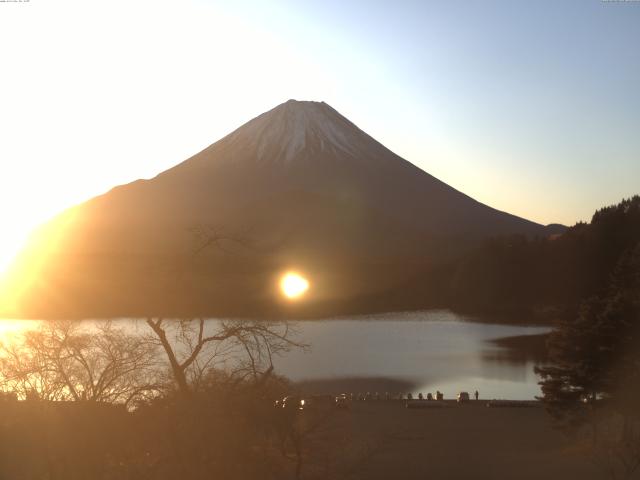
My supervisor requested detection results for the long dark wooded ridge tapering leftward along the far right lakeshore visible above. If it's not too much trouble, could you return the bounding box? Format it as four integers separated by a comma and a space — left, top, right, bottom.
280, 195, 640, 323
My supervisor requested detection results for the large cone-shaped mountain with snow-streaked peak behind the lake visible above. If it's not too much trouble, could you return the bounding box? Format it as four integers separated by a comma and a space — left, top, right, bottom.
3, 100, 548, 318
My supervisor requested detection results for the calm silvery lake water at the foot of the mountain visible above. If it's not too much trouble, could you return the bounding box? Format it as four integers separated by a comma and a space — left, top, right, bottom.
0, 310, 549, 399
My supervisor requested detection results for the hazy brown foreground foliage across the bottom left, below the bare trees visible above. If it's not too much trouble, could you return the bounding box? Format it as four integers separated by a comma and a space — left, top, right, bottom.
0, 377, 373, 480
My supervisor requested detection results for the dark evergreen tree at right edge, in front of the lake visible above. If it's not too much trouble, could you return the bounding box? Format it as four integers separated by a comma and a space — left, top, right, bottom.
536, 243, 640, 478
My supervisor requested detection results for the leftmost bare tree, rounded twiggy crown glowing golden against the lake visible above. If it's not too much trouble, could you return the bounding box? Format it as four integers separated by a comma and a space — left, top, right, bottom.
0, 321, 163, 407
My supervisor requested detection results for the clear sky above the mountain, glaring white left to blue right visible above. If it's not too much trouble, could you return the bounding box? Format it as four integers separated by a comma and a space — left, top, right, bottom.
0, 0, 640, 274
